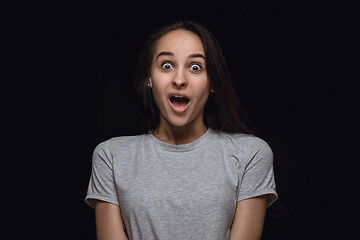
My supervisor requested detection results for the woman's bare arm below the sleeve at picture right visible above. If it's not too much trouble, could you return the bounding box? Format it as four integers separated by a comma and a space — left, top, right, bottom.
229, 195, 267, 240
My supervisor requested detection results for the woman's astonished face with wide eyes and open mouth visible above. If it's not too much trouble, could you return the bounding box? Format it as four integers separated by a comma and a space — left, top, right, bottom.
149, 29, 210, 127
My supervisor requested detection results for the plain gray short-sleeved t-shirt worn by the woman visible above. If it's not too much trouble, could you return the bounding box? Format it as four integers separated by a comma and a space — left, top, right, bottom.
85, 128, 277, 240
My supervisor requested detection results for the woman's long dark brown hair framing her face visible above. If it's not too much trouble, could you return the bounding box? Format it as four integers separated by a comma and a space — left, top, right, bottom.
137, 21, 254, 134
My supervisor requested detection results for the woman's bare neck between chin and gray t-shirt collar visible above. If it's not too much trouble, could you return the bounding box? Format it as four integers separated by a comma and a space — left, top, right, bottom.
153, 115, 207, 145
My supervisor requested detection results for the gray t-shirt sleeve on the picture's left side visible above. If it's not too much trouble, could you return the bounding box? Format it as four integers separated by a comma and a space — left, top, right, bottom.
85, 142, 119, 208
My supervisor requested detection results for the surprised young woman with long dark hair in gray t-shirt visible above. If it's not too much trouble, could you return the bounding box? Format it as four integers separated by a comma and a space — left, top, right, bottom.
86, 21, 277, 240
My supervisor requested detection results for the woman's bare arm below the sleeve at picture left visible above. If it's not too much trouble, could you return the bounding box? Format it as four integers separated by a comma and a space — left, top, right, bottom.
95, 201, 128, 240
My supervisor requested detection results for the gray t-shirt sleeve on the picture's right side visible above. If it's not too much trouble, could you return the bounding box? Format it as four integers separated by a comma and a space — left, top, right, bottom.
237, 138, 277, 206
